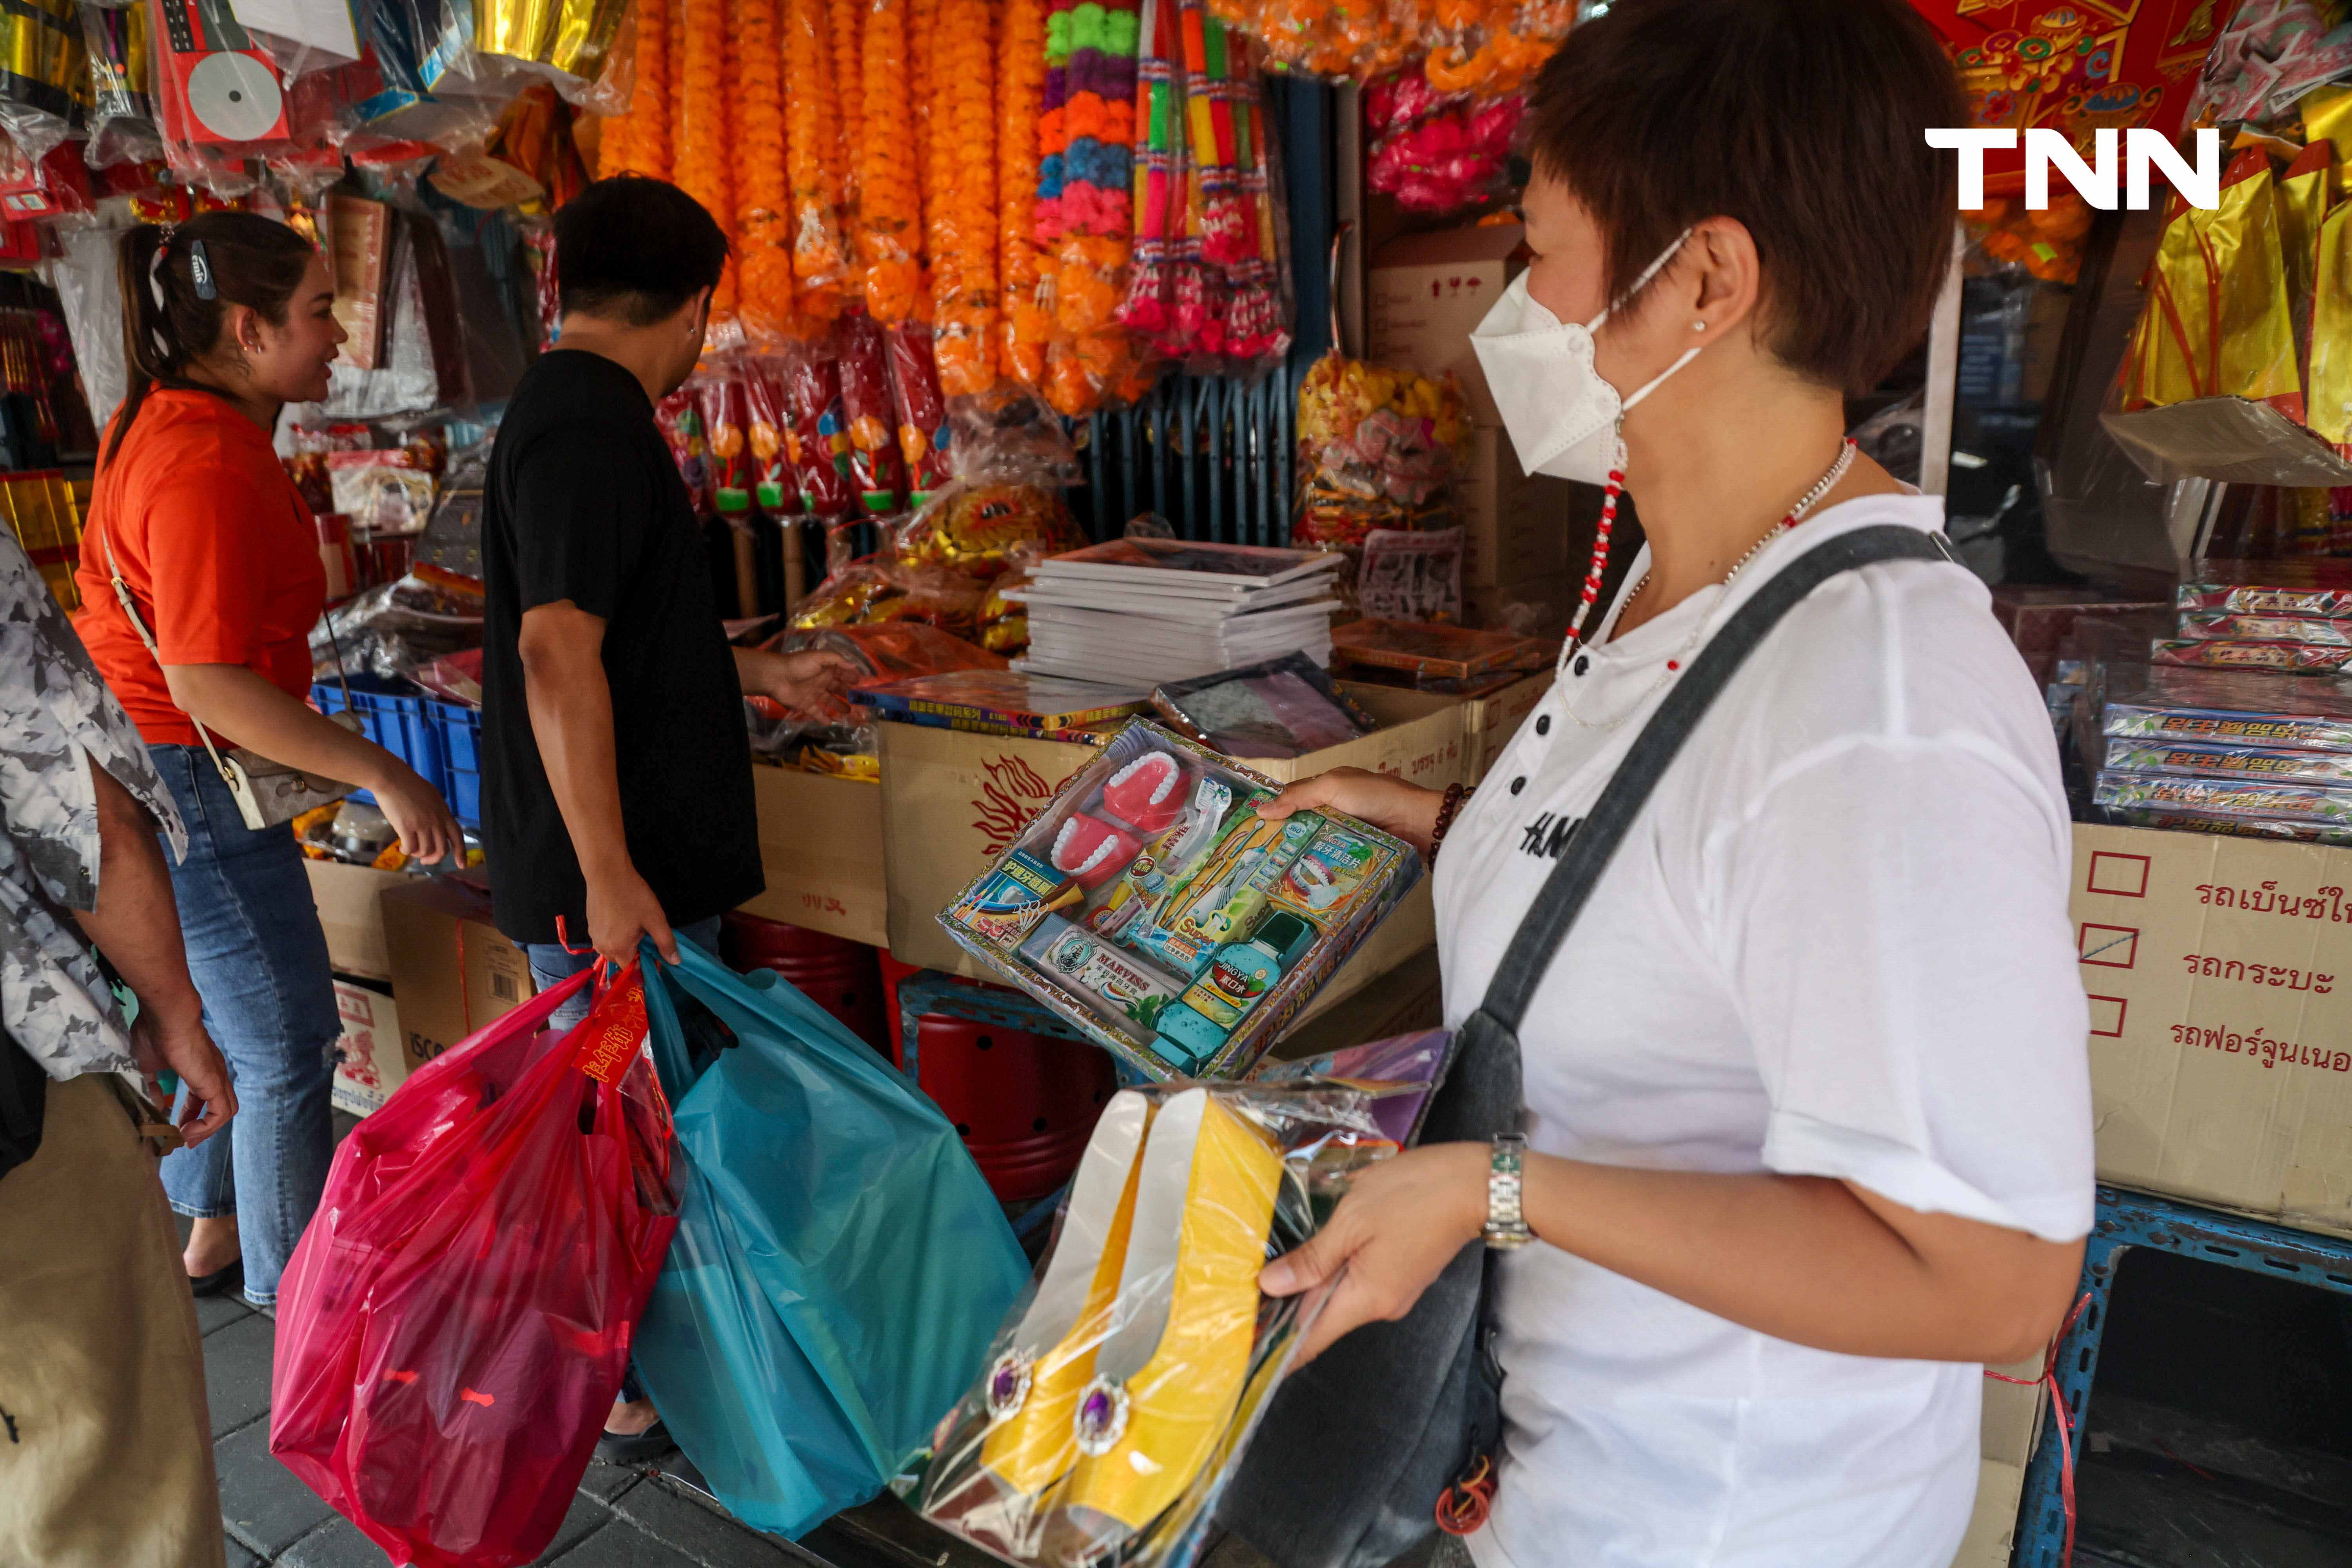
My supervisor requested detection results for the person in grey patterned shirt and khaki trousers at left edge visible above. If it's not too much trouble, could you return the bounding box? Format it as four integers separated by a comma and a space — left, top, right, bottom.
0, 529, 235, 1568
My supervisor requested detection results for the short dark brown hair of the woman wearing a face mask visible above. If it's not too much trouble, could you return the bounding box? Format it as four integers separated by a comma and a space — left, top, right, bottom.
1526, 0, 1973, 392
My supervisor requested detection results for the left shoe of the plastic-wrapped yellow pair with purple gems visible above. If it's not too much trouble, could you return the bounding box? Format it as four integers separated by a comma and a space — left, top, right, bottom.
922, 1091, 1152, 1556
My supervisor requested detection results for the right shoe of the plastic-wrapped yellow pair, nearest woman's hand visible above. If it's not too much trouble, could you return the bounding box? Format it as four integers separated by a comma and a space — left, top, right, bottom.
1042, 1089, 1282, 1563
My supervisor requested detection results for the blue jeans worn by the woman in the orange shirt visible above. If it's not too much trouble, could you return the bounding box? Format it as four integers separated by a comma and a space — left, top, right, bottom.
148, 745, 343, 1307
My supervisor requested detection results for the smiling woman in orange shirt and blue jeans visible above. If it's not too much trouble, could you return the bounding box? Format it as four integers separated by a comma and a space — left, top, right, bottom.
75, 212, 459, 1307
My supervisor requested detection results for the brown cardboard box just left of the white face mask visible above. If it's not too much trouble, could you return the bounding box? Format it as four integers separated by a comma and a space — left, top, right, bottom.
1364, 223, 1526, 425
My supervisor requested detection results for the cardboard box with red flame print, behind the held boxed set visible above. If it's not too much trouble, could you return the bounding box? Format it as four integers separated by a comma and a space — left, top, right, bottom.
880, 703, 1463, 985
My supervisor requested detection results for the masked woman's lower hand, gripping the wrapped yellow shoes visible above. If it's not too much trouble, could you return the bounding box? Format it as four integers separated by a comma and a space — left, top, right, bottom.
1258, 1143, 1491, 1366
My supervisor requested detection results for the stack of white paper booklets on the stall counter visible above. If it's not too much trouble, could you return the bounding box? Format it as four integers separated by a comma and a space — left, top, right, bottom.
1004, 538, 1341, 686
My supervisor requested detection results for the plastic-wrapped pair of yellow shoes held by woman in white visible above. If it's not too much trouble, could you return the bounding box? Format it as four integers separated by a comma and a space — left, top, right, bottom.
908, 1082, 1395, 1568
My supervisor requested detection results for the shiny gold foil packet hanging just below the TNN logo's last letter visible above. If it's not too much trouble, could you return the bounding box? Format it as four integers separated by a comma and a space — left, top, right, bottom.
2124, 148, 2303, 418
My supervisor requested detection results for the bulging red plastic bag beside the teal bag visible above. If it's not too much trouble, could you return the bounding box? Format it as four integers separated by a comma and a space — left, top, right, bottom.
270, 964, 677, 1568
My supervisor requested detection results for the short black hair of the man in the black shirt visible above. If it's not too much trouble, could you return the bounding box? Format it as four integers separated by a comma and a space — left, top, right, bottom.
555, 174, 727, 327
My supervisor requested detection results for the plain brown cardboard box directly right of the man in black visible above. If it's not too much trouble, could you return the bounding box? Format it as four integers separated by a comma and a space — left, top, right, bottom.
743, 766, 889, 947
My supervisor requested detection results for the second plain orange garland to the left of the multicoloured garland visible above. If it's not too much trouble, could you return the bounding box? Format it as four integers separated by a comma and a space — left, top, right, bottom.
934, 0, 997, 397
